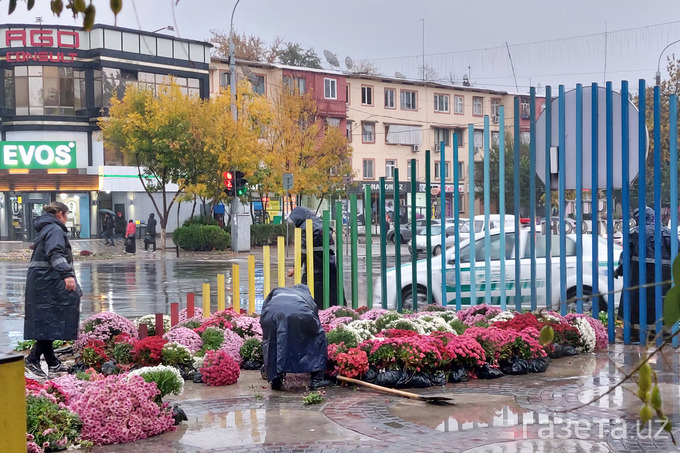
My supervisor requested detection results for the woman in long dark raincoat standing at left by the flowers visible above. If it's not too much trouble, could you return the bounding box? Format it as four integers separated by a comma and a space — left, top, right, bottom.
24, 201, 83, 379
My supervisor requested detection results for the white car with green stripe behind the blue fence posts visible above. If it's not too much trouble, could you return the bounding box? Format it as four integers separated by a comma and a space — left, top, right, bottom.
373, 229, 623, 311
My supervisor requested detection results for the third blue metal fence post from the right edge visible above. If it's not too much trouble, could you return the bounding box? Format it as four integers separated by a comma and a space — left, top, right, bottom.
636, 79, 647, 345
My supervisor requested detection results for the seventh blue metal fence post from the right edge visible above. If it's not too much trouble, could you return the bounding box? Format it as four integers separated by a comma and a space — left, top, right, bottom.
576, 83, 593, 313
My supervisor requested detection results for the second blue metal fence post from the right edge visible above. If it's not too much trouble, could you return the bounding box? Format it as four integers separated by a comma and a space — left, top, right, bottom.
652, 85, 660, 346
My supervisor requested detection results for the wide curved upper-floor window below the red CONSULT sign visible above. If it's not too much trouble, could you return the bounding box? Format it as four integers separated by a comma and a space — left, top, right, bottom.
5, 66, 87, 116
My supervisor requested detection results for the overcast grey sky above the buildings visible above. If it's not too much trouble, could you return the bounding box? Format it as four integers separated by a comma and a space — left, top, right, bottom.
0, 0, 680, 92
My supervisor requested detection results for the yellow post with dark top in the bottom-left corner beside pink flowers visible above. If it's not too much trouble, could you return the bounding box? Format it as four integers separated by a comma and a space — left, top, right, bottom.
0, 353, 26, 452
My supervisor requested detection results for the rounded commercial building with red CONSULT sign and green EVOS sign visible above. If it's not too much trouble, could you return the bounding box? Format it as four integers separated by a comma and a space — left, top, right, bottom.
0, 25, 212, 241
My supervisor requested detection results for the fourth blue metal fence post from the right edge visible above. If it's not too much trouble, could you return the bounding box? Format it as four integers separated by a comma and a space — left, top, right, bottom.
621, 80, 630, 344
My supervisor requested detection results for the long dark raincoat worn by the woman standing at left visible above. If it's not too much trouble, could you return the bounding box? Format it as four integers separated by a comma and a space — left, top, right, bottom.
24, 214, 82, 340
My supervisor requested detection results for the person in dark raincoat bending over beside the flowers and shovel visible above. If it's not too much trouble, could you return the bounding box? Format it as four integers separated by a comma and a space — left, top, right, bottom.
260, 285, 330, 390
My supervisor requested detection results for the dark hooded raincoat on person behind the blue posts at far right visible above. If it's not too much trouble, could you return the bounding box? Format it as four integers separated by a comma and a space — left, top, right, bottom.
616, 207, 678, 327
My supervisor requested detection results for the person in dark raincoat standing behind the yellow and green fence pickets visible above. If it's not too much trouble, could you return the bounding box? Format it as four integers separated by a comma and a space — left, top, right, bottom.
288, 206, 347, 310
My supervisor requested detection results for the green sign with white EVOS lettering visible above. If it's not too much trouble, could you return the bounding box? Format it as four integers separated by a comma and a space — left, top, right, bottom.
0, 141, 76, 170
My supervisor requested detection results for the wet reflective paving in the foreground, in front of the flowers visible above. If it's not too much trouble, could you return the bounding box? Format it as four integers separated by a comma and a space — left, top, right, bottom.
78, 345, 680, 453
